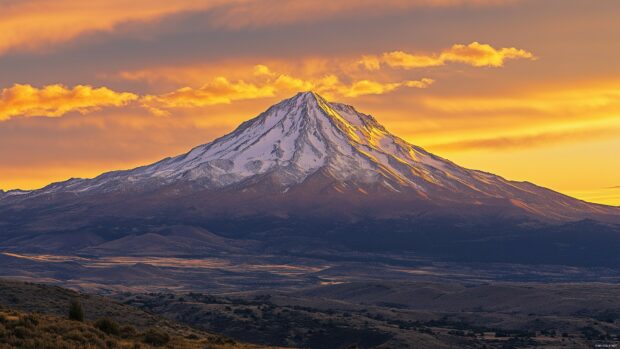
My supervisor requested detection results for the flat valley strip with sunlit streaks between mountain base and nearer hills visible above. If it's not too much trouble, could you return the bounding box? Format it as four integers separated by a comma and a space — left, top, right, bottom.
0, 251, 620, 294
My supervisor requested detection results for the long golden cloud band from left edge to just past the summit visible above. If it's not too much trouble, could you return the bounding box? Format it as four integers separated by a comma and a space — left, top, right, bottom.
0, 65, 433, 121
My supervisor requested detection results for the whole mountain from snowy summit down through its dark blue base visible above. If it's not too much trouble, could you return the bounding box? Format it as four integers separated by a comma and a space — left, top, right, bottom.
0, 92, 620, 266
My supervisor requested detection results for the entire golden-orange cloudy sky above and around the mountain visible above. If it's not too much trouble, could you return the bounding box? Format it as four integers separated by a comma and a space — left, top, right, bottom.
0, 0, 620, 205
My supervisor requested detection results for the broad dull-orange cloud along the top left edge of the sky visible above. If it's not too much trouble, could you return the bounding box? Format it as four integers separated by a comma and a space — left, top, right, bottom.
0, 0, 514, 54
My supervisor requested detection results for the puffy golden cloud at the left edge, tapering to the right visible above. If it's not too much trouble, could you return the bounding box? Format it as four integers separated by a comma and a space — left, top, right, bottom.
0, 84, 138, 121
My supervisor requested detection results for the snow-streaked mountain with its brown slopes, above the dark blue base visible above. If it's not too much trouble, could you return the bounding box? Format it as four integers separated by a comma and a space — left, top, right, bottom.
0, 92, 619, 220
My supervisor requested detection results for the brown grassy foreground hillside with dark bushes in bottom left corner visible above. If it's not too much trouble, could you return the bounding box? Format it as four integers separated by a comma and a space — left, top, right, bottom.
0, 280, 272, 349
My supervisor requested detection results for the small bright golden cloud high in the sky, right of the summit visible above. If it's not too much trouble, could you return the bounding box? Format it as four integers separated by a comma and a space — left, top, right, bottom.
366, 41, 535, 70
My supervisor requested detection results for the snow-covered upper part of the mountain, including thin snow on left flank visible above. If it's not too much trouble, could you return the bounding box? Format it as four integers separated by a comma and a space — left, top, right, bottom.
21, 92, 496, 196
